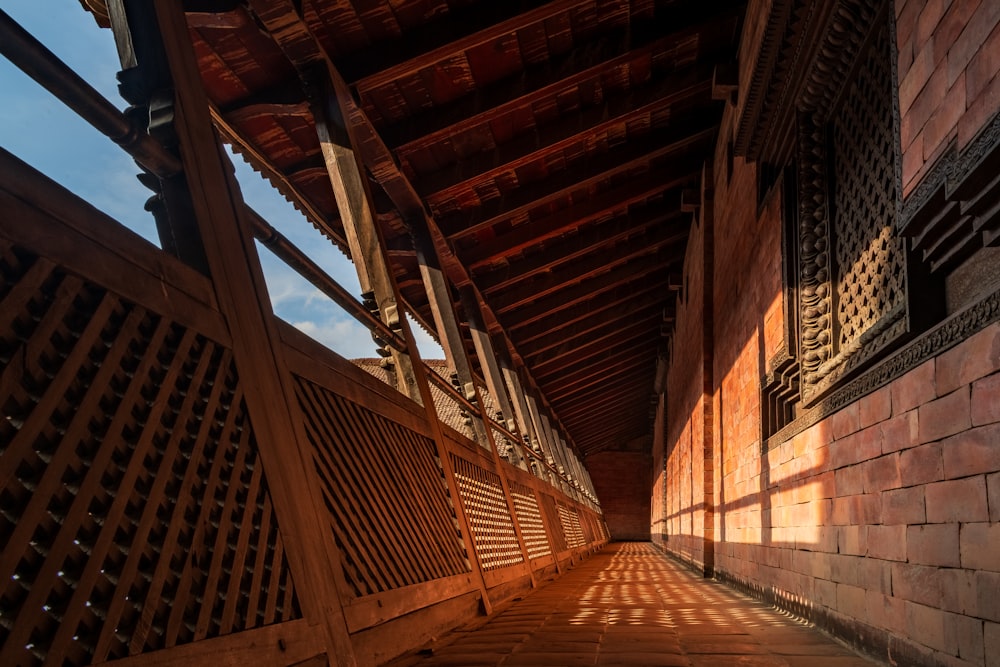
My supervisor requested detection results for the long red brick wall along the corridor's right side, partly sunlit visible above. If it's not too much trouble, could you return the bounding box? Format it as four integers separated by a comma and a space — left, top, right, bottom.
653, 0, 1000, 667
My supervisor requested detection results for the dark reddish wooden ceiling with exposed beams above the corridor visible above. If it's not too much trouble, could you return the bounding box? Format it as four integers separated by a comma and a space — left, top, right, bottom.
176, 0, 744, 457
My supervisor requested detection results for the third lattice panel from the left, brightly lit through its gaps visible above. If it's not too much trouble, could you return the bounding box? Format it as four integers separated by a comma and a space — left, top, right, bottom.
451, 454, 524, 570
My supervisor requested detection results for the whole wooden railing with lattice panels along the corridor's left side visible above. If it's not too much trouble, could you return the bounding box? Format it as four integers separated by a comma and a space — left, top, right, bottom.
0, 9, 608, 665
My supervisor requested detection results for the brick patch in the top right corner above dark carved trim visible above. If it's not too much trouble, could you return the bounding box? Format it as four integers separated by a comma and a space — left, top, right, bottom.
896, 0, 1000, 194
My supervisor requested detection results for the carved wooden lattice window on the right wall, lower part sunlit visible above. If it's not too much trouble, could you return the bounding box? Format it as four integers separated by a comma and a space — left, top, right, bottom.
798, 3, 908, 405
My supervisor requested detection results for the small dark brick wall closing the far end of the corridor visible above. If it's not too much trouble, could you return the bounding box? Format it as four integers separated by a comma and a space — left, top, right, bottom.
587, 450, 652, 541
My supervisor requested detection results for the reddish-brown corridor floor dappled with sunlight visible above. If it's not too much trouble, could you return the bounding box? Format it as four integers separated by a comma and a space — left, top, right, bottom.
393, 543, 878, 667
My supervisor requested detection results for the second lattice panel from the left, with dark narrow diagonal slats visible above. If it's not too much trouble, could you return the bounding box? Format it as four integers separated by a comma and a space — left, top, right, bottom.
296, 378, 471, 596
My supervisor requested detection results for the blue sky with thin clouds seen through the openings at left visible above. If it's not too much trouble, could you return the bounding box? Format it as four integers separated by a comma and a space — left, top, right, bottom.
0, 0, 443, 358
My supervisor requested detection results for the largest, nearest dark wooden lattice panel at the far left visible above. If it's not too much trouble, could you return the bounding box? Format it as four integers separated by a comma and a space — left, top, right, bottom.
0, 244, 301, 665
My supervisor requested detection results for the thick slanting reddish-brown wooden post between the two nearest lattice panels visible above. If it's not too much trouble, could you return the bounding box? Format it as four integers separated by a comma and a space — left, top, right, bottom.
155, 0, 355, 665
